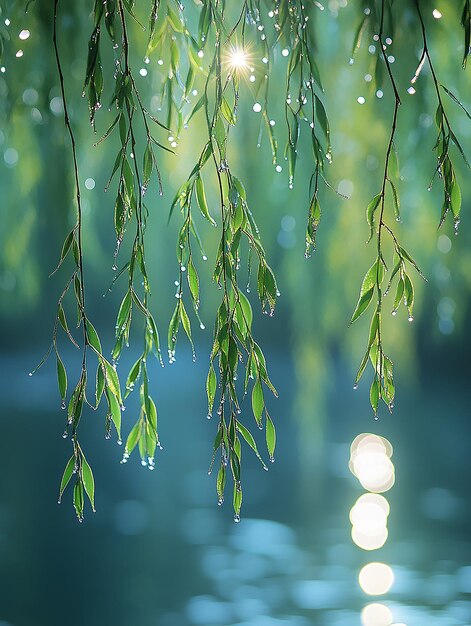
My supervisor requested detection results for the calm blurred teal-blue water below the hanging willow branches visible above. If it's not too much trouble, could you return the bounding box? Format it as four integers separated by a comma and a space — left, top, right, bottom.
0, 346, 471, 626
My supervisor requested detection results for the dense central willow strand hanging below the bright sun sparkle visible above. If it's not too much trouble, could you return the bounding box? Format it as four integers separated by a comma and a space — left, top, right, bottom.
169, 2, 278, 521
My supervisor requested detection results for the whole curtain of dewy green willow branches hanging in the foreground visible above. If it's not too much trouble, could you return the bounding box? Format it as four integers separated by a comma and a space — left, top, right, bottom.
17, 0, 471, 521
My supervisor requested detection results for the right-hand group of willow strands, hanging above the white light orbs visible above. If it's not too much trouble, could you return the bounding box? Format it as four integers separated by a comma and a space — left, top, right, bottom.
350, 0, 471, 417
